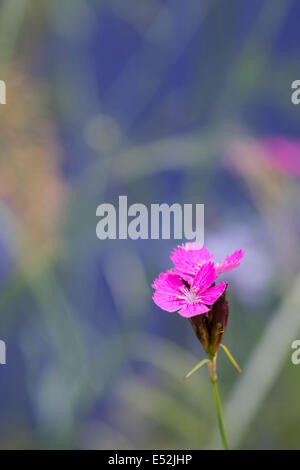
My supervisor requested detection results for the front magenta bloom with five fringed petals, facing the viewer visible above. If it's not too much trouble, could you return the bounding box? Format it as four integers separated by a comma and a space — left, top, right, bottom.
152, 262, 226, 318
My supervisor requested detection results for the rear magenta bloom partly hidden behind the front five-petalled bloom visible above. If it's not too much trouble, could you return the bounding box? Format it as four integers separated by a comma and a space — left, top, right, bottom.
170, 242, 244, 282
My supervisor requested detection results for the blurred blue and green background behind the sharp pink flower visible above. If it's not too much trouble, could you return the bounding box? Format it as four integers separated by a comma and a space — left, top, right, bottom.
0, 0, 300, 449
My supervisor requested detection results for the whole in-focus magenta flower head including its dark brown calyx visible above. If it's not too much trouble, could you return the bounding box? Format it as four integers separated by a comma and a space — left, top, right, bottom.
152, 242, 244, 357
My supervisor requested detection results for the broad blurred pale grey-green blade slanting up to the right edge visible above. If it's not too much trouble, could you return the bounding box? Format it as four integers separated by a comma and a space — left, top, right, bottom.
210, 276, 300, 449
